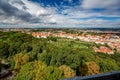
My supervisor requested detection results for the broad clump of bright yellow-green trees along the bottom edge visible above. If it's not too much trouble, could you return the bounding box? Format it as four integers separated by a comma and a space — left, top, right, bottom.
15, 61, 62, 80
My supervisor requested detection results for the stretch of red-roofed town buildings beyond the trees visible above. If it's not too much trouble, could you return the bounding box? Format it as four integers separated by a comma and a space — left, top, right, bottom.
32, 31, 120, 54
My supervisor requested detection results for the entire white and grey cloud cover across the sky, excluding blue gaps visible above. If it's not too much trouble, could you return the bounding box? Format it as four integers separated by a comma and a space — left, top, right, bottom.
0, 0, 120, 27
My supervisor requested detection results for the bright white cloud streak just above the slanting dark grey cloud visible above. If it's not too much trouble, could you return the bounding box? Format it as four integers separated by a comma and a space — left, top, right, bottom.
10, 0, 49, 16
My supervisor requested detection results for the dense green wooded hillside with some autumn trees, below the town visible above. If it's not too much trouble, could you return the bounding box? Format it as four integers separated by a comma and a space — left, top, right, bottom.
0, 32, 120, 80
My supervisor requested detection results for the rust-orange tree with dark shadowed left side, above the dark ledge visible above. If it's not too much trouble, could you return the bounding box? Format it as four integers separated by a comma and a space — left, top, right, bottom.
79, 61, 100, 76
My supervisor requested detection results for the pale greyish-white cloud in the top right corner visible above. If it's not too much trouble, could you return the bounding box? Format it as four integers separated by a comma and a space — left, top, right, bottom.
81, 0, 120, 9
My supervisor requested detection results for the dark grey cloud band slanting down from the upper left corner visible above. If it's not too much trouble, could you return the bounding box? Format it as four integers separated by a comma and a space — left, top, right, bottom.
0, 0, 40, 23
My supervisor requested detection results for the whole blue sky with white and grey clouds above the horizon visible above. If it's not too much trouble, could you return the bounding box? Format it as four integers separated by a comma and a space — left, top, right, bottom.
0, 0, 120, 28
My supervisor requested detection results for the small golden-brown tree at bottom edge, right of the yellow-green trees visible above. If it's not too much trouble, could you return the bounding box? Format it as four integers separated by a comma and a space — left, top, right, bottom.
59, 65, 76, 78
